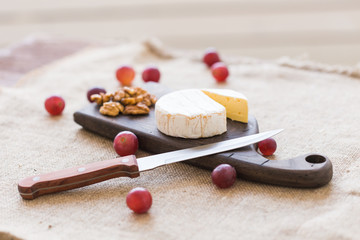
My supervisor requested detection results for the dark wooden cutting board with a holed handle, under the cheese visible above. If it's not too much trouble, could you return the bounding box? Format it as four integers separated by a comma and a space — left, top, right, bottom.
74, 83, 332, 188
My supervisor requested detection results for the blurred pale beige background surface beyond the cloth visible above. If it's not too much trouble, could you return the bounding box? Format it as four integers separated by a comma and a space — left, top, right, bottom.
0, 0, 360, 65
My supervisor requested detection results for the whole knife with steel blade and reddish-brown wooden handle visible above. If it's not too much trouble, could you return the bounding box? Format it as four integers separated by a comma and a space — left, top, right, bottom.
18, 129, 283, 200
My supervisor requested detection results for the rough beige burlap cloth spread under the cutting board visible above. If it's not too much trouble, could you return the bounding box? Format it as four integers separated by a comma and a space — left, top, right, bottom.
0, 42, 360, 240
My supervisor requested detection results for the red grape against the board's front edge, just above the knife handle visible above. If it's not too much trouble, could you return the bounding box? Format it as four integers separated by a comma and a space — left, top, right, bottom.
113, 131, 139, 156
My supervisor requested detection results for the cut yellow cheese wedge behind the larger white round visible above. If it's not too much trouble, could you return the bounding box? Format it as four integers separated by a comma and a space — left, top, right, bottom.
202, 89, 248, 123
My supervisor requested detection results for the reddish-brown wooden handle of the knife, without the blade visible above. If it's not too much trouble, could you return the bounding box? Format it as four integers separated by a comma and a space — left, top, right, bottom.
18, 155, 140, 199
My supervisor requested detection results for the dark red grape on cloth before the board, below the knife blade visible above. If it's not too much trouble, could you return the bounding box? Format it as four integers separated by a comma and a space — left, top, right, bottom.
211, 164, 236, 188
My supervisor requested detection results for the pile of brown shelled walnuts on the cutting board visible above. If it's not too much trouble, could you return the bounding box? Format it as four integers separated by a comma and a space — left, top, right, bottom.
90, 87, 156, 117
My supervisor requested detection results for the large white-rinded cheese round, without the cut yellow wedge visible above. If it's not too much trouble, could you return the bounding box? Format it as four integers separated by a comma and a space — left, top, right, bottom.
155, 89, 226, 138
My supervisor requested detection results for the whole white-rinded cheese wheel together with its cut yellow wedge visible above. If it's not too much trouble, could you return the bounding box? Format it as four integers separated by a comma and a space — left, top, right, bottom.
155, 89, 248, 138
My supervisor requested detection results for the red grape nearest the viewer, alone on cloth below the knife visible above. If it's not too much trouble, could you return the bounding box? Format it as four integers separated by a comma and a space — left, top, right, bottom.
126, 187, 152, 213
